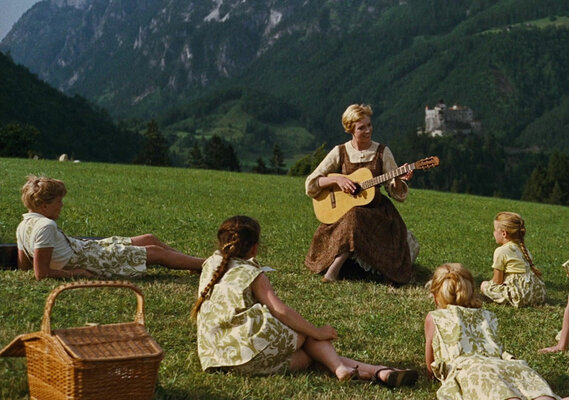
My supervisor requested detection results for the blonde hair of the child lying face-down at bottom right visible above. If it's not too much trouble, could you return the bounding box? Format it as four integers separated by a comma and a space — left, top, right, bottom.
430, 263, 482, 308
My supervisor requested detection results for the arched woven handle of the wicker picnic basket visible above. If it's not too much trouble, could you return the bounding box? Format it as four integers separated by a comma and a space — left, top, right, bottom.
41, 281, 144, 335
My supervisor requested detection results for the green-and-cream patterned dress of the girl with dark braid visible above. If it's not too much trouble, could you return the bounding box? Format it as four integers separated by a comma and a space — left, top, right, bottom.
197, 251, 298, 375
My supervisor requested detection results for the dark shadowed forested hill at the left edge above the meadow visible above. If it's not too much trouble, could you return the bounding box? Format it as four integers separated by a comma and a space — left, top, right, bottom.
0, 53, 141, 163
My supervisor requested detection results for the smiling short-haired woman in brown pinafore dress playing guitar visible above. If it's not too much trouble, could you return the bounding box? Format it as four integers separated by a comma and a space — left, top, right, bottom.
305, 104, 419, 284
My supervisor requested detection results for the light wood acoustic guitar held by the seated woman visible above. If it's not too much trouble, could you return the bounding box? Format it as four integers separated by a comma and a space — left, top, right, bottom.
312, 156, 439, 224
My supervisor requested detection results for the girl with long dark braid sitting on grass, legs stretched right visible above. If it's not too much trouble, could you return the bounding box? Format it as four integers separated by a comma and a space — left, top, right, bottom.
192, 216, 417, 386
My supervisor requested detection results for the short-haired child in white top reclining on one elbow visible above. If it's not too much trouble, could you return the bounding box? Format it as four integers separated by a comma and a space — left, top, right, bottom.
16, 176, 204, 280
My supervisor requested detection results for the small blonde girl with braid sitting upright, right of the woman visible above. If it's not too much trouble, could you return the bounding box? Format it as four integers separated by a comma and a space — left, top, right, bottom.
480, 212, 545, 307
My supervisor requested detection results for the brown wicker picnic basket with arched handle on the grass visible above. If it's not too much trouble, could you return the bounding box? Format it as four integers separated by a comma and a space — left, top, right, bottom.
0, 281, 163, 400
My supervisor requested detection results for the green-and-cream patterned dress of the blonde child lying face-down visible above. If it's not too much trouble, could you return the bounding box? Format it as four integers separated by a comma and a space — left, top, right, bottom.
429, 305, 560, 400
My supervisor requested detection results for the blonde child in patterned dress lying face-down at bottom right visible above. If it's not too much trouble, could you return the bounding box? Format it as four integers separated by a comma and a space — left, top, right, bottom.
425, 263, 560, 400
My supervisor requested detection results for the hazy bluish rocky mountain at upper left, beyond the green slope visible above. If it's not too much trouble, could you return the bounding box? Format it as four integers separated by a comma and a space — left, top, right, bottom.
0, 0, 392, 116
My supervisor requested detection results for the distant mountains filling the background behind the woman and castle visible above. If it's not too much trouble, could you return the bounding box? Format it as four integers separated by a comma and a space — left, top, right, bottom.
0, 0, 569, 197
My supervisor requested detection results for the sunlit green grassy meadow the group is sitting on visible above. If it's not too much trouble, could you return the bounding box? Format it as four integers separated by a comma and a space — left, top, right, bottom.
0, 159, 569, 400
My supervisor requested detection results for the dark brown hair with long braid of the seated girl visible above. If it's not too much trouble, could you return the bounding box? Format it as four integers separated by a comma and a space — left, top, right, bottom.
191, 215, 261, 319
